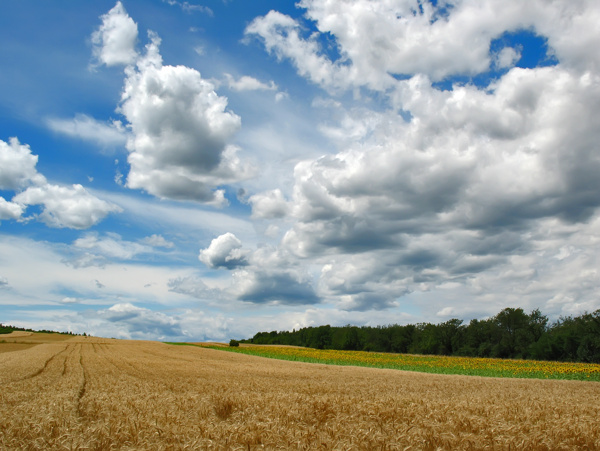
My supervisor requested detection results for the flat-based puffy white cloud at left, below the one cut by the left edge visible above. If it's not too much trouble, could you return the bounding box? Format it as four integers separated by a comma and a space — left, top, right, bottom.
14, 184, 121, 229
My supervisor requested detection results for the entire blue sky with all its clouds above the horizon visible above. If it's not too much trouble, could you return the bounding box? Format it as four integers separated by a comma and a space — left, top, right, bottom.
0, 0, 600, 341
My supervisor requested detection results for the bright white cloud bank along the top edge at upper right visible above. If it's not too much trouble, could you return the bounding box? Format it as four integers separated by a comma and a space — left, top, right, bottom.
246, 0, 600, 90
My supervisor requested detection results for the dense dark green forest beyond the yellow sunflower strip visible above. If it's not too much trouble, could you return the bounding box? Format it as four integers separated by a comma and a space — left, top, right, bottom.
241, 308, 600, 363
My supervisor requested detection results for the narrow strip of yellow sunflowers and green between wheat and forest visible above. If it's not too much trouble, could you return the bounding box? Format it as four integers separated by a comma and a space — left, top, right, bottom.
185, 343, 600, 382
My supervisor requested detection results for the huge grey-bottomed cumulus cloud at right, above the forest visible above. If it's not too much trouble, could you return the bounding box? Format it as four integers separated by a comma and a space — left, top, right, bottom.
264, 61, 600, 313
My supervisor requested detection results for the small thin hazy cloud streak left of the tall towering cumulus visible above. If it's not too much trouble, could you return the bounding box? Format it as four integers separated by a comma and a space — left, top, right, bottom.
47, 114, 127, 147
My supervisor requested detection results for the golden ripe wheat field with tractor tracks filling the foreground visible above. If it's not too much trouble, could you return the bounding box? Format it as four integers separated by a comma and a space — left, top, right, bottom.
0, 336, 600, 450
